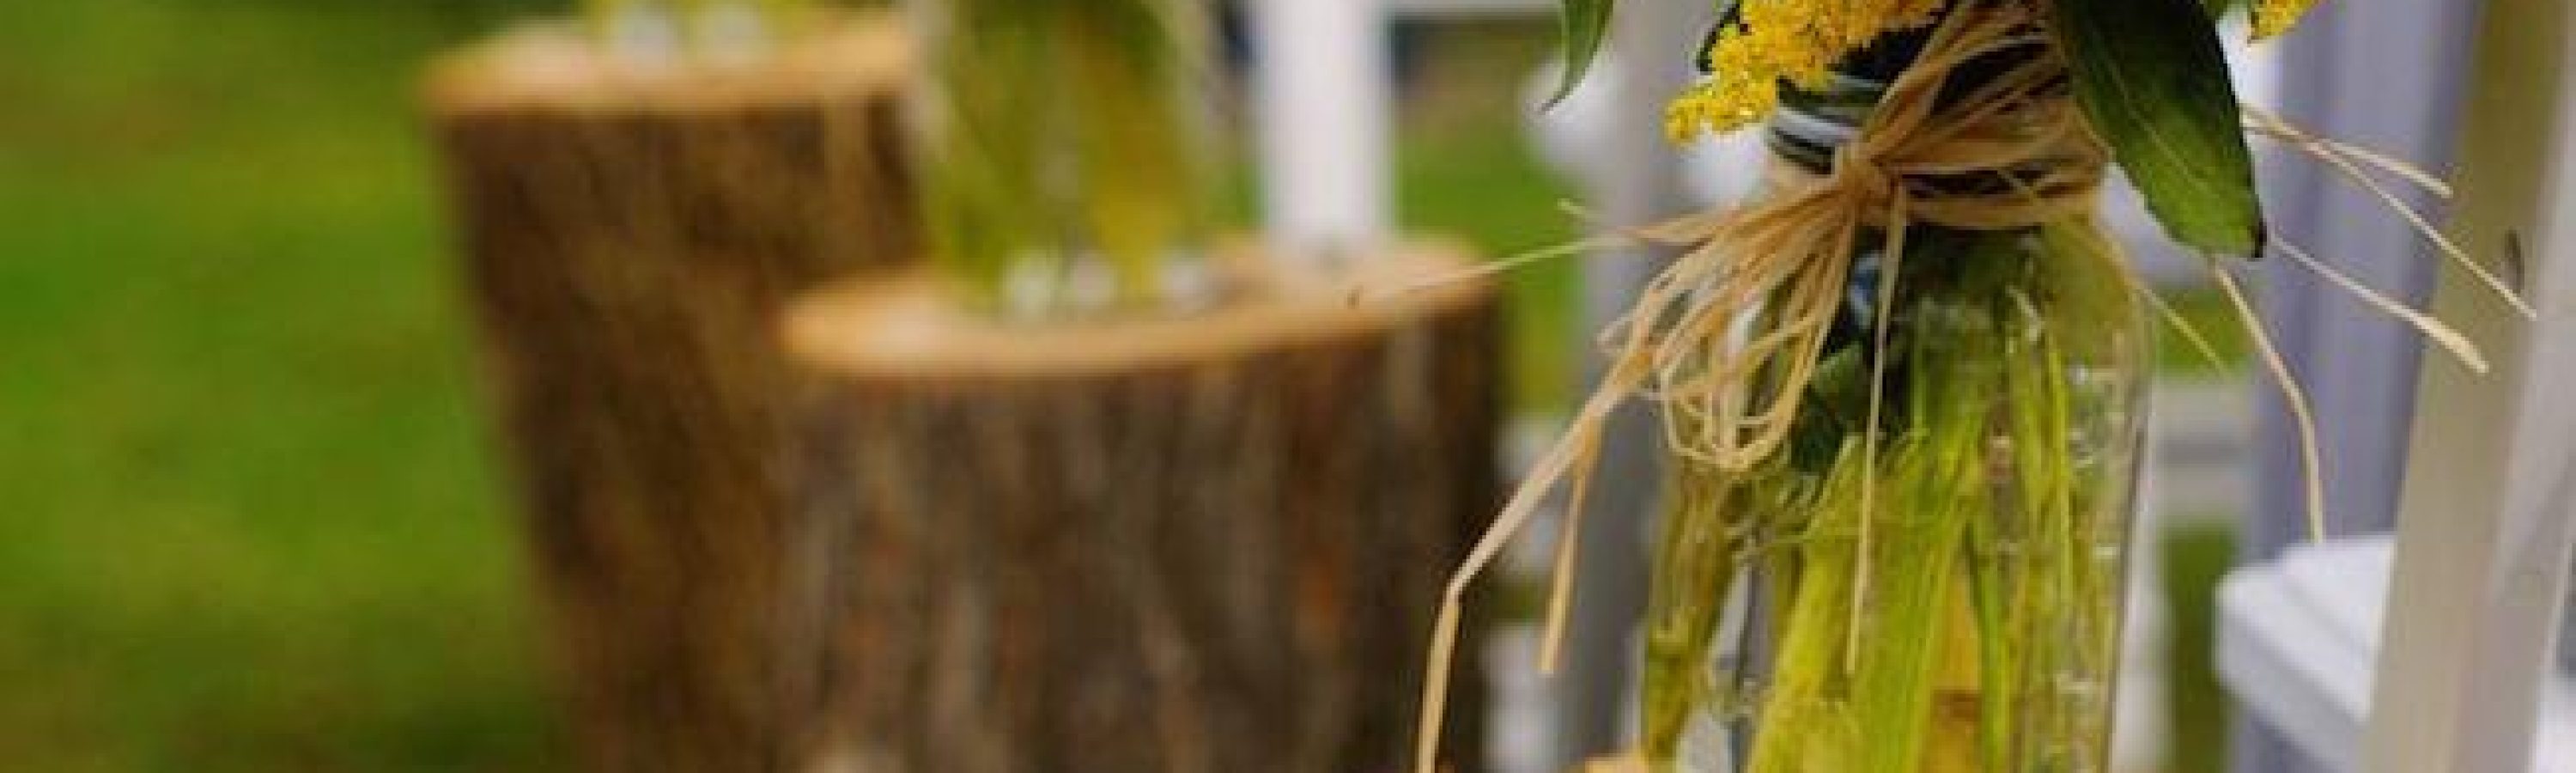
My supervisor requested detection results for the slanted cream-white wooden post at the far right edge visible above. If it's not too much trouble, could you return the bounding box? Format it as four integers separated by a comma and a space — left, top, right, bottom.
2367, 0, 2576, 773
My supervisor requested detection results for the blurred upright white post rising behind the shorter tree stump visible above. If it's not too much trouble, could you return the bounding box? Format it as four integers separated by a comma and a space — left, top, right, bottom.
1252, 0, 1394, 255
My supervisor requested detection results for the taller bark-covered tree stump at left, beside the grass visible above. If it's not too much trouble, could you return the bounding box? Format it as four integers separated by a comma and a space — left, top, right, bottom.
428, 21, 917, 773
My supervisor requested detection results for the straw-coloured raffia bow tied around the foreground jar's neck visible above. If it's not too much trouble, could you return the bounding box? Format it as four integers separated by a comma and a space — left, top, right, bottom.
1414, 3, 2110, 773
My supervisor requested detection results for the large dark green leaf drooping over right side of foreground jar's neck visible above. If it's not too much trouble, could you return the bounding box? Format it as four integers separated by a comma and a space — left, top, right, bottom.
2050, 0, 2264, 255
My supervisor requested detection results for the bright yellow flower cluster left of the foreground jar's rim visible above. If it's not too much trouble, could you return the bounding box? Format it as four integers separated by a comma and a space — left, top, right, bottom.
1664, 0, 1937, 142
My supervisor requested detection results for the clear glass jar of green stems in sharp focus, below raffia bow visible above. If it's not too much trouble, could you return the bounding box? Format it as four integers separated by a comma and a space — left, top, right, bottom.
1643, 77, 2151, 773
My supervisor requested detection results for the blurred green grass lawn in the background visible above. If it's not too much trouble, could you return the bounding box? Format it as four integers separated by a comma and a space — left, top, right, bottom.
0, 0, 2249, 770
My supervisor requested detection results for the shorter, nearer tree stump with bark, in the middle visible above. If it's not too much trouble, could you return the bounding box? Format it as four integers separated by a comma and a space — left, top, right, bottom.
788, 247, 1499, 773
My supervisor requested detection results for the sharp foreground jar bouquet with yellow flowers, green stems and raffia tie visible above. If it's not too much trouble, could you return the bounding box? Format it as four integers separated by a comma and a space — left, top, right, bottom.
1419, 0, 2519, 773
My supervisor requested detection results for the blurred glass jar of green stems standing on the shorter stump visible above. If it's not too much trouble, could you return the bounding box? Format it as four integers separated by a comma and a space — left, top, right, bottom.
907, 0, 1213, 320
